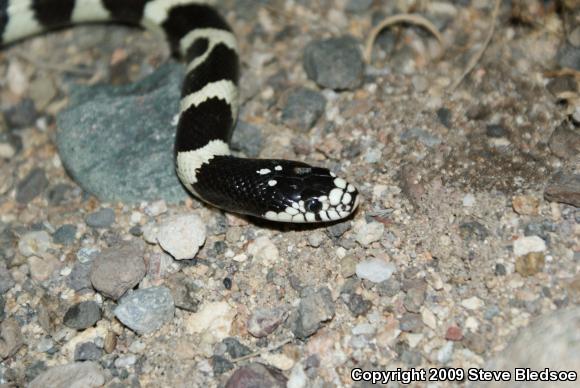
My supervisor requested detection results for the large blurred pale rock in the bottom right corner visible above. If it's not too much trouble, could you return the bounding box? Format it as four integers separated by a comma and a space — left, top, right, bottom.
481, 306, 580, 388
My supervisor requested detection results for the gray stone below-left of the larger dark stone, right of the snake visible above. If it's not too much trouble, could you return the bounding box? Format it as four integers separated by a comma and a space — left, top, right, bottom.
282, 88, 326, 131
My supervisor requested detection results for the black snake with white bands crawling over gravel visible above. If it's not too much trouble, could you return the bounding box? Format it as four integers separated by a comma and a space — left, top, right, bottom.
0, 0, 360, 223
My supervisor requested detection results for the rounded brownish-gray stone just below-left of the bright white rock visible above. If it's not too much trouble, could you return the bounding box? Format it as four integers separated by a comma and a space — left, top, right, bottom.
91, 240, 147, 300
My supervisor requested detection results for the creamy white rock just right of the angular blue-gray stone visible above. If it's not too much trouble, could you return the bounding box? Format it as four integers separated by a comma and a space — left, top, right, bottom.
186, 302, 236, 343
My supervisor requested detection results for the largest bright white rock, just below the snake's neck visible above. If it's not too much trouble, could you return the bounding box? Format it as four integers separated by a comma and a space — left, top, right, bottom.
153, 214, 206, 260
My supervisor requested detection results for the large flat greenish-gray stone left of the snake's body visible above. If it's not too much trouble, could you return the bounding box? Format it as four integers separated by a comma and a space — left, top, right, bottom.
56, 64, 186, 203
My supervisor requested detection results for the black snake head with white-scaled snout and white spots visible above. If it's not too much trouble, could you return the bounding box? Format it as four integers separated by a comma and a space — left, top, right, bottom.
257, 161, 359, 222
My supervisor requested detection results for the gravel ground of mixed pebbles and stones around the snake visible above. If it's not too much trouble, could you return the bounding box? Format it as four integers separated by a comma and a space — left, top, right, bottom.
0, 0, 580, 388
